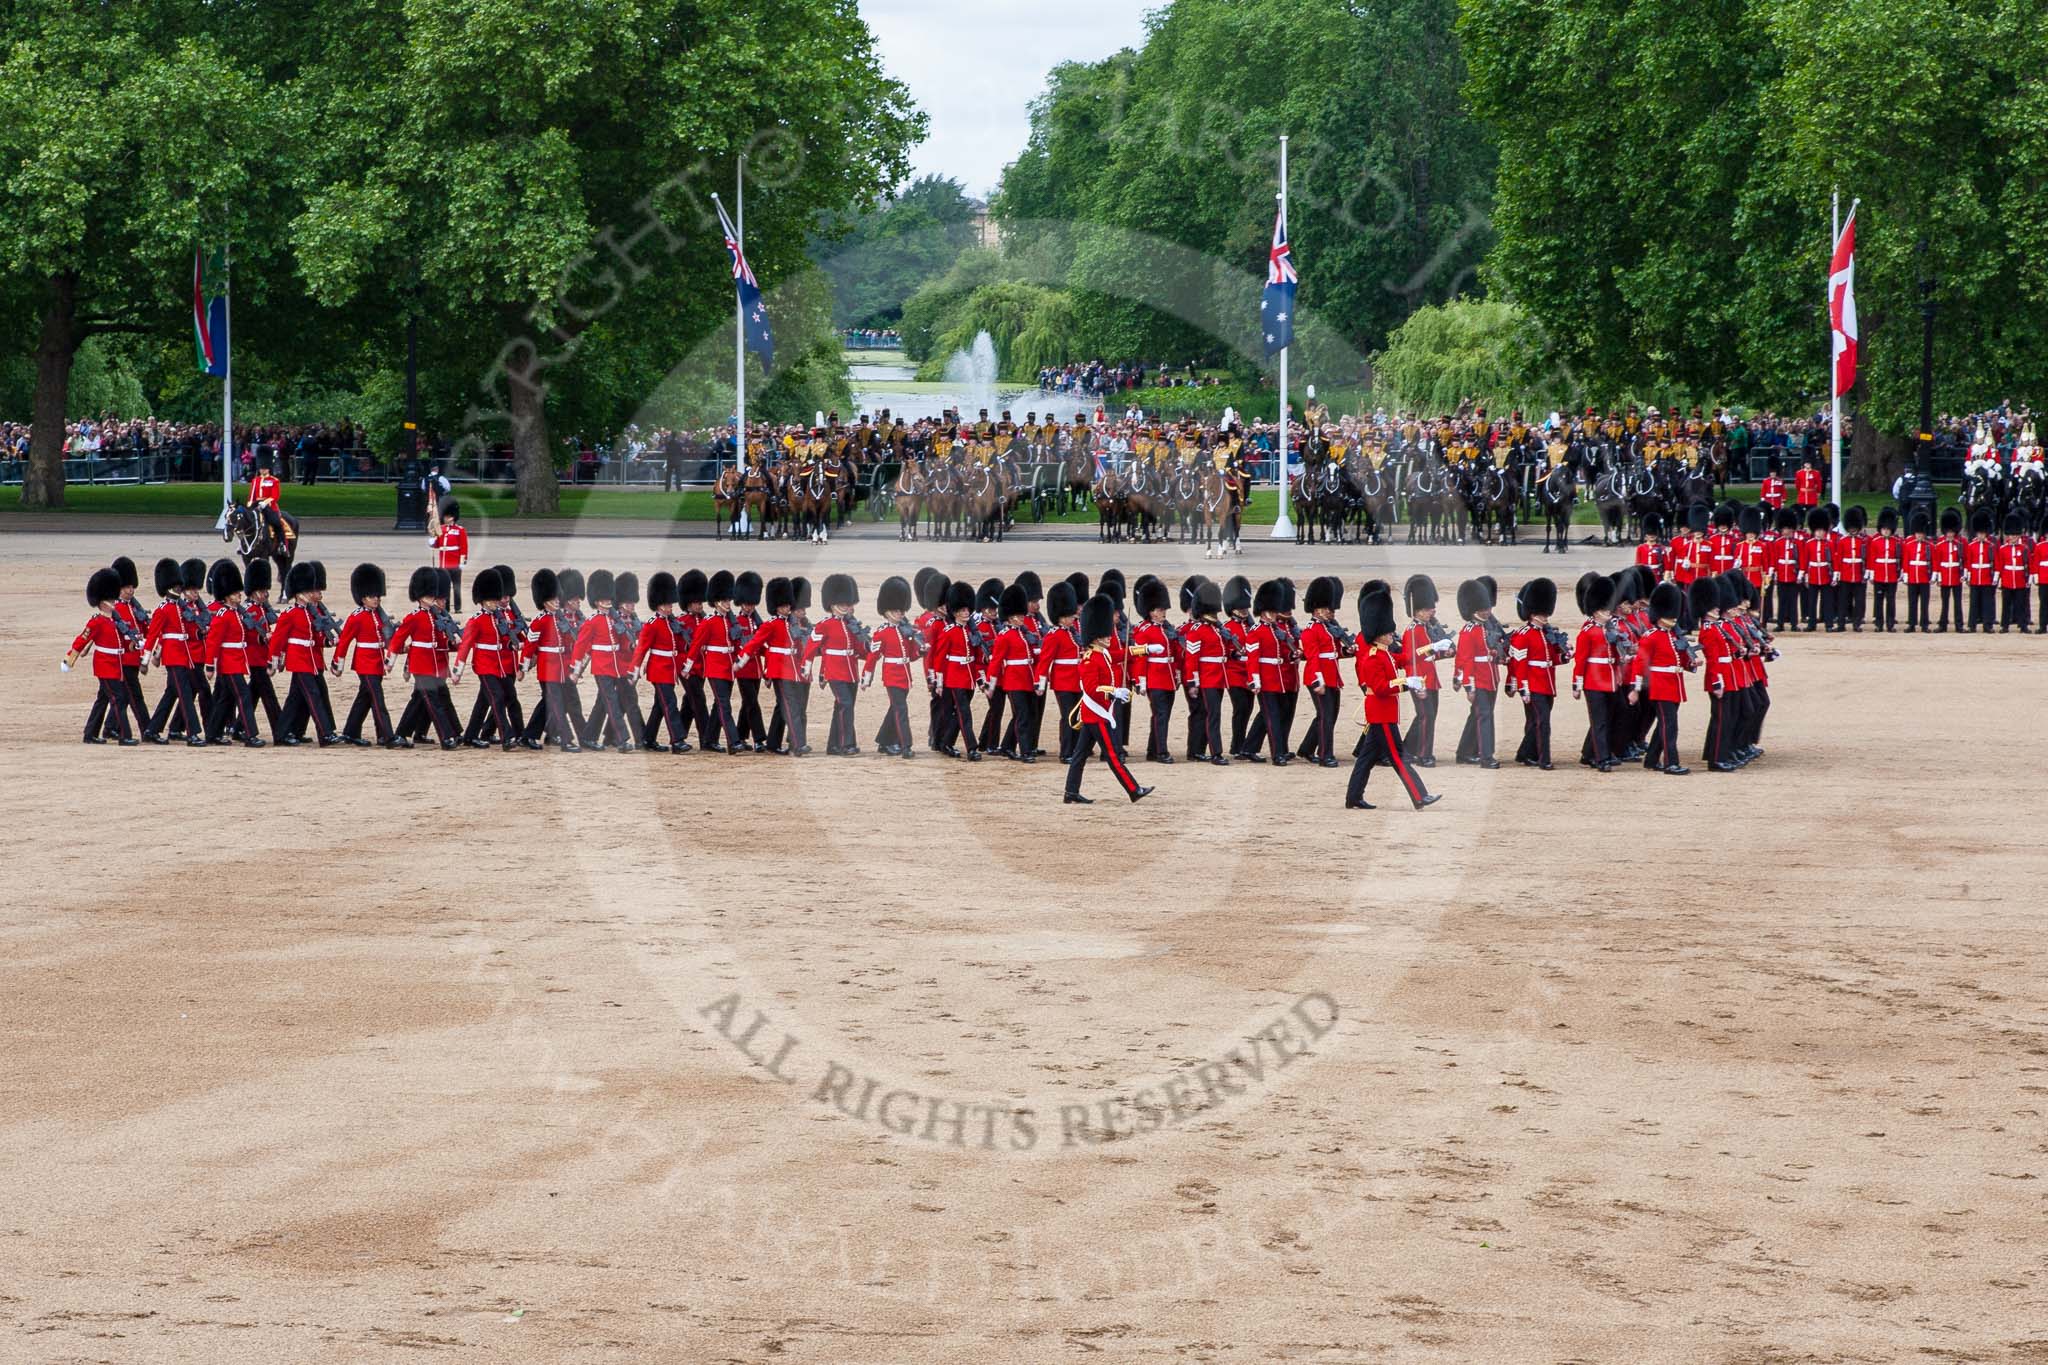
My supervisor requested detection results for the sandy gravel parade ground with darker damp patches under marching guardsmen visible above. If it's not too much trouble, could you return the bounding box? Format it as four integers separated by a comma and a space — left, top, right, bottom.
0, 520, 2048, 1365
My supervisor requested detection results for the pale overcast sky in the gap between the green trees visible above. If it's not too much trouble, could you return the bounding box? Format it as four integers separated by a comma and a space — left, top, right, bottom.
860, 0, 1165, 199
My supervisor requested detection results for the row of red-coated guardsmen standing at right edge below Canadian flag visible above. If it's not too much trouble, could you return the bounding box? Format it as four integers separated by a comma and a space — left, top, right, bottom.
1636, 503, 2048, 634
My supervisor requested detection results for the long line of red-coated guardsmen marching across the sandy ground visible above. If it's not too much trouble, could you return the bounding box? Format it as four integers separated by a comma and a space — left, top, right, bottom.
63, 559, 1776, 806
